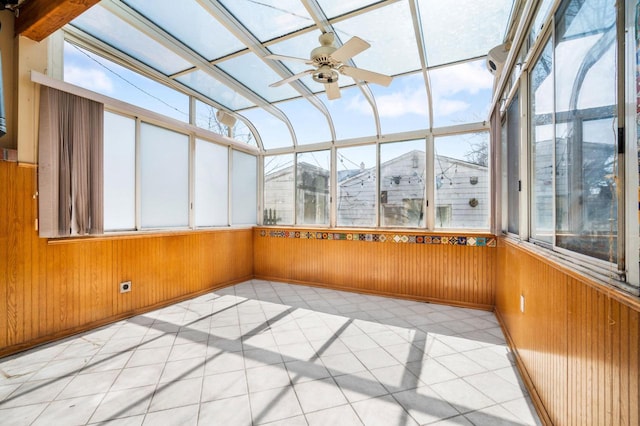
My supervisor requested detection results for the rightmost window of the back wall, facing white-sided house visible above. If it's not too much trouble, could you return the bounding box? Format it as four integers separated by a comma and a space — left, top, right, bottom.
434, 132, 490, 229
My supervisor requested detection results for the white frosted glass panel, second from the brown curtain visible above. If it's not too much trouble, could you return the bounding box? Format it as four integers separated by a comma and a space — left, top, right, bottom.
140, 123, 189, 228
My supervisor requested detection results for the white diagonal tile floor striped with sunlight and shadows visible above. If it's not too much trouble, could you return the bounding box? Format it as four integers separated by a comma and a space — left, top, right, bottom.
0, 280, 540, 426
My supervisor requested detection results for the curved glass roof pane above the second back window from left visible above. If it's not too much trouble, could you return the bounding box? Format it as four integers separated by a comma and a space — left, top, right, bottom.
276, 98, 331, 145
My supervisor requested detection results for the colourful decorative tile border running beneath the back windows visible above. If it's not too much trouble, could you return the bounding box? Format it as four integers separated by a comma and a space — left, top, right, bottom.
260, 229, 496, 247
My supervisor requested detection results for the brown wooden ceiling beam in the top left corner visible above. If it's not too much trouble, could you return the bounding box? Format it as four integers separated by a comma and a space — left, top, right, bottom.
15, 0, 100, 41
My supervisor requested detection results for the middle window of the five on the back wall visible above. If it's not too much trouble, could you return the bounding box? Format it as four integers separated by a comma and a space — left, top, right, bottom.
336, 145, 378, 226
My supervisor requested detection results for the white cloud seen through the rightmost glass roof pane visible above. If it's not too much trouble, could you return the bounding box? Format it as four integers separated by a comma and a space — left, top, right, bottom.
431, 61, 493, 96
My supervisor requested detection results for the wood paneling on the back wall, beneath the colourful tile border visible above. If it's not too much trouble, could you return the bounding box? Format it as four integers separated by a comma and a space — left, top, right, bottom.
254, 228, 497, 309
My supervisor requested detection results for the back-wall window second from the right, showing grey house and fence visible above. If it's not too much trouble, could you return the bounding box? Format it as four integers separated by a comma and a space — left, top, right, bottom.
380, 140, 426, 228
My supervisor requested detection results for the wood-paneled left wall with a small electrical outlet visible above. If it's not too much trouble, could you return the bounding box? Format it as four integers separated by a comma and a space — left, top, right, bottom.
0, 161, 253, 356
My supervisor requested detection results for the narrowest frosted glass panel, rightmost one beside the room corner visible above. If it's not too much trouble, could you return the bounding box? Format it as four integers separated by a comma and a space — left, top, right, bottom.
231, 151, 258, 225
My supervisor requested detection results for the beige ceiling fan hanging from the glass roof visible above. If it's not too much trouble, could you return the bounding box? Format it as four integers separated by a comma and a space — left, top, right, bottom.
265, 33, 392, 99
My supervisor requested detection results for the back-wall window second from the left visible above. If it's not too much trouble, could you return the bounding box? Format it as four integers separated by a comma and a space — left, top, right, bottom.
296, 150, 331, 225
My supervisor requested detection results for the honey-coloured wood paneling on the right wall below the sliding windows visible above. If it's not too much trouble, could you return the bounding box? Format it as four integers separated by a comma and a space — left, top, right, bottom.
496, 240, 640, 425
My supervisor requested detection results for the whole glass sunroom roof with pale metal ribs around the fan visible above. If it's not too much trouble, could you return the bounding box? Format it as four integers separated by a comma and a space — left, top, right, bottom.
66, 0, 514, 153
